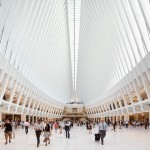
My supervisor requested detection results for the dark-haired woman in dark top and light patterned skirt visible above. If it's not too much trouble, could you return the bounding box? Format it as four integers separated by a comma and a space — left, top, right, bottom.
44, 123, 51, 146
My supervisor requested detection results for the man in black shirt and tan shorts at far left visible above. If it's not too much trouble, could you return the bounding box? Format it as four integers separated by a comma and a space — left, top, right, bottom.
4, 119, 12, 144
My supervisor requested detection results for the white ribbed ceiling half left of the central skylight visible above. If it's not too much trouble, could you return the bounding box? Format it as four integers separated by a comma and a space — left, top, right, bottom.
0, 0, 72, 102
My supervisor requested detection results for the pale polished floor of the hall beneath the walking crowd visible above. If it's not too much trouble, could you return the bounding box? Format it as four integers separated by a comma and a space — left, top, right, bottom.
0, 126, 150, 150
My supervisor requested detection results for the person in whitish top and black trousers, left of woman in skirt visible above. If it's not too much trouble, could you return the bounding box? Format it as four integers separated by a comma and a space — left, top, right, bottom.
34, 120, 43, 147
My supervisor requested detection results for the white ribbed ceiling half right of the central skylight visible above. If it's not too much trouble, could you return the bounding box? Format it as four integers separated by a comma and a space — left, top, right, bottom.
77, 0, 150, 103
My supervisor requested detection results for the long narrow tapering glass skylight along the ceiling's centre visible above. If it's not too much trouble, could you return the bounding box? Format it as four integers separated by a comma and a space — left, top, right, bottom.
68, 0, 81, 91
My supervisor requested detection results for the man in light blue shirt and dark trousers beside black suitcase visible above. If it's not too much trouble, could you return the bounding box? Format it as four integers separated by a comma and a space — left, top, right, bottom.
99, 118, 107, 145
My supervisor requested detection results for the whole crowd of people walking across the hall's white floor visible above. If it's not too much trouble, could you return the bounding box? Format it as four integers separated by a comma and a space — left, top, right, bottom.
0, 118, 149, 147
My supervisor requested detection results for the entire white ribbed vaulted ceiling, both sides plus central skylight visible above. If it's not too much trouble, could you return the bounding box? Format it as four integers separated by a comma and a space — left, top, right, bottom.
0, 0, 150, 103
